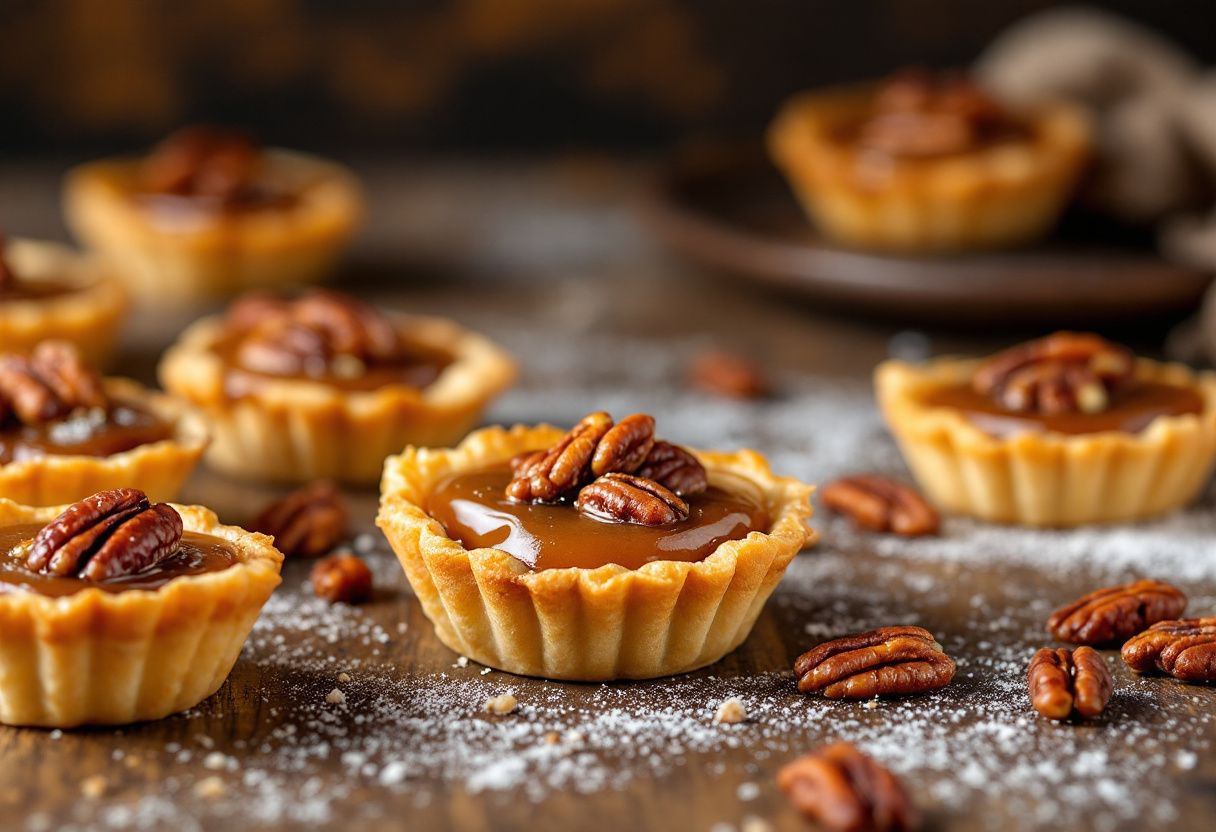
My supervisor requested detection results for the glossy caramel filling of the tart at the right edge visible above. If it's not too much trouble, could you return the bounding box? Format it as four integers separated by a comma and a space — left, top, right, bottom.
923, 381, 1204, 438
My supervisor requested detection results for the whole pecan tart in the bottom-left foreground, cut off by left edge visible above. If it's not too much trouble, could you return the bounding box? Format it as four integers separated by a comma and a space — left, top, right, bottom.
0, 488, 282, 727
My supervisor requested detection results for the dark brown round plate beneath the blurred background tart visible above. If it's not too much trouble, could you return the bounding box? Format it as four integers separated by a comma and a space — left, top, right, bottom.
643, 147, 1211, 325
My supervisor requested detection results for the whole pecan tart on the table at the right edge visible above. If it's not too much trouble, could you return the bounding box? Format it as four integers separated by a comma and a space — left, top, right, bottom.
876, 332, 1216, 527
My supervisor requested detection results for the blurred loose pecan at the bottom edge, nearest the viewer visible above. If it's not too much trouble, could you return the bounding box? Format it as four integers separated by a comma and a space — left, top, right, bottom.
777, 742, 921, 832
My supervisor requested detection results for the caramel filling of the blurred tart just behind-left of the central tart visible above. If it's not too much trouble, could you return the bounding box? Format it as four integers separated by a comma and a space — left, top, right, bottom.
213, 335, 454, 399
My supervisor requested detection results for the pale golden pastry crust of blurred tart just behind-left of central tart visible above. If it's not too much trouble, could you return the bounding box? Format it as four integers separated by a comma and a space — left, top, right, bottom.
161, 315, 516, 483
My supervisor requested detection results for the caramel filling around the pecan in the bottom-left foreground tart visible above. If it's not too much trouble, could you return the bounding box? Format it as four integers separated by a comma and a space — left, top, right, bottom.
0, 523, 238, 597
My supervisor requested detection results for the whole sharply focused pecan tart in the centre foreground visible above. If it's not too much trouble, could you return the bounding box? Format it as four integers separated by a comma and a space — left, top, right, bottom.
377, 414, 815, 681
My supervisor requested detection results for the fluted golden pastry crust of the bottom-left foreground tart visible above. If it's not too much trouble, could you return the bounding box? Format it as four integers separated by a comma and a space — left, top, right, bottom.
0, 500, 283, 727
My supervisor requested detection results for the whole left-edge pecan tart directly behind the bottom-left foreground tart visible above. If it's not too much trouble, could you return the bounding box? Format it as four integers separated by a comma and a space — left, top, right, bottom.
0, 341, 207, 506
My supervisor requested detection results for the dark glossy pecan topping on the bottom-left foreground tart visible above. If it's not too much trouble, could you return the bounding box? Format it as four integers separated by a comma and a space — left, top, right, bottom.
26, 488, 182, 581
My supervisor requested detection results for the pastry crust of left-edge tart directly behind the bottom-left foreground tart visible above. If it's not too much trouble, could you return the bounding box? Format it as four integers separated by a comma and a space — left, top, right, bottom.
0, 378, 208, 506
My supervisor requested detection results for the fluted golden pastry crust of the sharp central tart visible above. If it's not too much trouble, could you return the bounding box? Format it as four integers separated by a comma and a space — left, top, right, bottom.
376, 425, 815, 681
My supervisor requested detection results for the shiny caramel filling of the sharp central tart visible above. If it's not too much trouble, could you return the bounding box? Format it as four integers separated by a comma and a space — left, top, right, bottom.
426, 465, 770, 570
